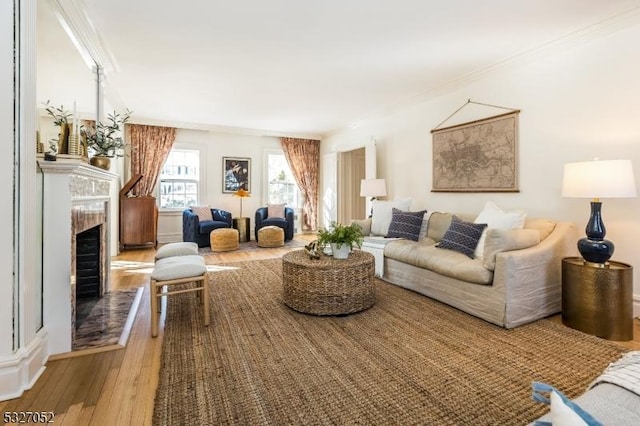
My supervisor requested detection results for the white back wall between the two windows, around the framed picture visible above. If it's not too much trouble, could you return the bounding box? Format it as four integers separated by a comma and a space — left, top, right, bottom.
158, 129, 282, 243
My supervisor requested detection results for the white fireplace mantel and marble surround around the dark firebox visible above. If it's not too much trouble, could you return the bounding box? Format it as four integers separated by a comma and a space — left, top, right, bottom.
38, 159, 119, 355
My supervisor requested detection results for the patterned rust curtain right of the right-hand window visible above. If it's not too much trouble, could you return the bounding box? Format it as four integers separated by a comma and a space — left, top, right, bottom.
281, 138, 320, 231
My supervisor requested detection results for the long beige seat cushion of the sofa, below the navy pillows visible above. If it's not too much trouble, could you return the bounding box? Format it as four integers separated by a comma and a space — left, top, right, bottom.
384, 241, 493, 285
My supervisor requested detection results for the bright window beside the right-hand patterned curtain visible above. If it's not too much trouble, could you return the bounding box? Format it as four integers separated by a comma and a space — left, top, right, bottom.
267, 152, 300, 207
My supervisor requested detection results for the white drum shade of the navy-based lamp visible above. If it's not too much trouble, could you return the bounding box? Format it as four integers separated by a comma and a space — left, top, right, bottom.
562, 160, 636, 198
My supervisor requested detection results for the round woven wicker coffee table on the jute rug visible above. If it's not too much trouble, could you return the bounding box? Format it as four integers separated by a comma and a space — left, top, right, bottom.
282, 250, 375, 315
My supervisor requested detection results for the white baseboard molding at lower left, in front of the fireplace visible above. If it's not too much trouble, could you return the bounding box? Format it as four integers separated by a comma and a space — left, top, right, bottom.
0, 328, 48, 401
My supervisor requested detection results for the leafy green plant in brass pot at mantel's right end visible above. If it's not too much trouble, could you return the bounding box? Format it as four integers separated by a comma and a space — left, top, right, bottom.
81, 109, 132, 170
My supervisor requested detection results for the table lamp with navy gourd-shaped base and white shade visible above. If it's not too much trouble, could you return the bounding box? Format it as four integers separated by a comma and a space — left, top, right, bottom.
562, 160, 636, 264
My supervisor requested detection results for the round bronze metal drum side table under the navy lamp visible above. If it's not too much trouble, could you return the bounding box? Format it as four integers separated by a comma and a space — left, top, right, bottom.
562, 257, 633, 341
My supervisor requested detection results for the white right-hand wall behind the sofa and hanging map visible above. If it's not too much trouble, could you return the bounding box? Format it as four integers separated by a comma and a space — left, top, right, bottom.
322, 25, 640, 307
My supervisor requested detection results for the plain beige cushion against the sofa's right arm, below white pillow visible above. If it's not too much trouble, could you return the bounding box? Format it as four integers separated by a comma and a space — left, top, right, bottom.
479, 228, 540, 271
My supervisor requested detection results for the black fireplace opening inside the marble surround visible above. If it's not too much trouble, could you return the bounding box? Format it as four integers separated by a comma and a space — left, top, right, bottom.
76, 225, 102, 329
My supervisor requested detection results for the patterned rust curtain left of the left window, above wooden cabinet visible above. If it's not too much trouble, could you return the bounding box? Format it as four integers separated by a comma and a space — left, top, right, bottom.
126, 124, 176, 197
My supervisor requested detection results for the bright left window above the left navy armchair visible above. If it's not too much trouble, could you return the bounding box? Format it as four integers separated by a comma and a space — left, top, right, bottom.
160, 149, 200, 209
